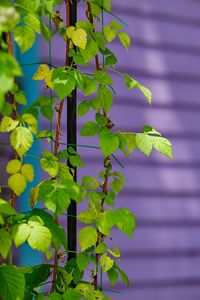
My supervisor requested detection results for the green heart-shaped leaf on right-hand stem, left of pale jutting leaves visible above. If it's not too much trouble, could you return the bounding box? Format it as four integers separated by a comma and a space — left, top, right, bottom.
99, 128, 119, 157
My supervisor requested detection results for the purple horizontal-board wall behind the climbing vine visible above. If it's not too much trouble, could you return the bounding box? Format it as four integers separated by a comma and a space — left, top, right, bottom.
41, 0, 200, 300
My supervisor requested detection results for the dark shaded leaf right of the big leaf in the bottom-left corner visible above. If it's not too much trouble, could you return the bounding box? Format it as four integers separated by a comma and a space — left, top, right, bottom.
20, 264, 51, 289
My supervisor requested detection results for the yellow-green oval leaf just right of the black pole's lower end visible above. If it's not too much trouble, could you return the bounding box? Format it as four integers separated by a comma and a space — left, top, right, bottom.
78, 226, 97, 251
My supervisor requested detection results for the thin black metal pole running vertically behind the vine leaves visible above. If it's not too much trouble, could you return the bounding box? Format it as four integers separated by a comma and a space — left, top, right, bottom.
67, 0, 77, 260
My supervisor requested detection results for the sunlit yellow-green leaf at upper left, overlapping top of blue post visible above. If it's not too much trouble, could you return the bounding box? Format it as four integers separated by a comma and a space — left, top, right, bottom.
14, 25, 35, 52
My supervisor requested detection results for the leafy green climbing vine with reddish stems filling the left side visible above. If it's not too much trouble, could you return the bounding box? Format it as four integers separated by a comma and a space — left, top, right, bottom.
0, 0, 172, 300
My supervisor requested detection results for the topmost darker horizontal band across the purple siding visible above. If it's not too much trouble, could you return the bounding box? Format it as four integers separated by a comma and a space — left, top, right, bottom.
113, 5, 200, 28
